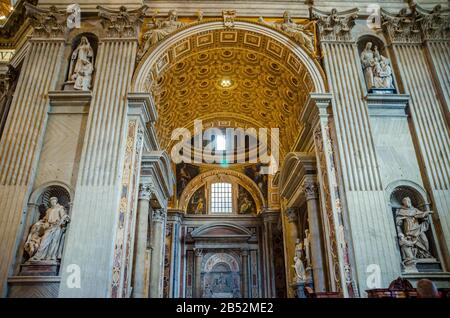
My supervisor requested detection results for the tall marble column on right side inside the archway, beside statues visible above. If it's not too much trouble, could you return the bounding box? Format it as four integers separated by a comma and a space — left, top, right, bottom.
302, 179, 326, 292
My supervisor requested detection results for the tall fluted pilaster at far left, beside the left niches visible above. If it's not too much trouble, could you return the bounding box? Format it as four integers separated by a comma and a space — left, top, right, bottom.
0, 4, 66, 296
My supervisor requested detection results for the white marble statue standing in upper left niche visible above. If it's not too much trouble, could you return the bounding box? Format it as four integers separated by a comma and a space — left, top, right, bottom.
69, 36, 94, 91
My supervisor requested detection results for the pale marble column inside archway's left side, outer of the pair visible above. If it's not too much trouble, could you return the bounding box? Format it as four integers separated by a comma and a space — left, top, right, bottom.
133, 183, 153, 298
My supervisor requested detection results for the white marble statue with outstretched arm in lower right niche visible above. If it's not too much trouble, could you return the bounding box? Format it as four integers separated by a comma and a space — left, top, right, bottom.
395, 197, 433, 269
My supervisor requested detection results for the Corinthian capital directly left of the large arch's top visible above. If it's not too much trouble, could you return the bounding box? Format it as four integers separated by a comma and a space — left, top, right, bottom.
97, 6, 147, 37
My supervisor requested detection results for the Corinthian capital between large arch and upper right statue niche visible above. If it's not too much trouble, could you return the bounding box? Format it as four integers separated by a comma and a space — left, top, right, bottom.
311, 8, 358, 41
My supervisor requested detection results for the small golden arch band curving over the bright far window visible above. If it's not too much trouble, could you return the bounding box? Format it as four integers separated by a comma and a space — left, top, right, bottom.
178, 169, 266, 211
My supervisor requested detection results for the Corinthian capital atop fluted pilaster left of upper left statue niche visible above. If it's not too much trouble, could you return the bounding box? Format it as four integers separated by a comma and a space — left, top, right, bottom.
24, 3, 67, 37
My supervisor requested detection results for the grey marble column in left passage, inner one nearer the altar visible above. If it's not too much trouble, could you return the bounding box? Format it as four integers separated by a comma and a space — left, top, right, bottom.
150, 209, 166, 298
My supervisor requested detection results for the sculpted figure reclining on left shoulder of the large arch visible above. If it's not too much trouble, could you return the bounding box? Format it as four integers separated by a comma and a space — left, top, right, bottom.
140, 10, 185, 57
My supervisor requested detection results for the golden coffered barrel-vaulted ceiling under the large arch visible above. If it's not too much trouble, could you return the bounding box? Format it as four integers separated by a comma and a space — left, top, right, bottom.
148, 29, 314, 155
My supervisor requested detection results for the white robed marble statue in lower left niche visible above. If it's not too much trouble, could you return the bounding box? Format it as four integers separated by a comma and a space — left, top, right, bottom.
25, 197, 70, 262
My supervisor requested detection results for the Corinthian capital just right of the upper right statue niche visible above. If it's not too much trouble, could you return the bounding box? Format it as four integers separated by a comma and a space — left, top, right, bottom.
381, 8, 422, 43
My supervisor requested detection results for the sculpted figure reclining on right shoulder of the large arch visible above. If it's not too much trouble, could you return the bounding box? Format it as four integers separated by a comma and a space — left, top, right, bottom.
259, 11, 314, 52
